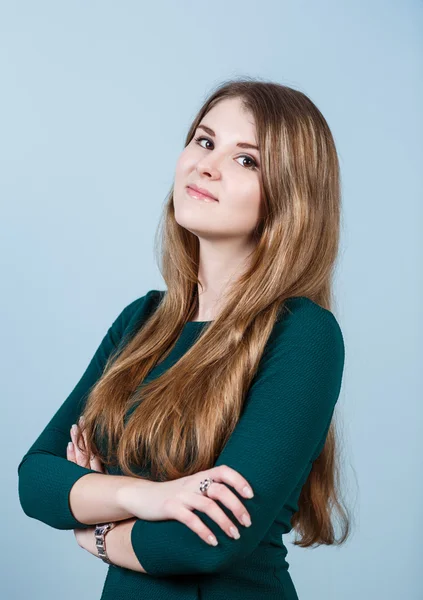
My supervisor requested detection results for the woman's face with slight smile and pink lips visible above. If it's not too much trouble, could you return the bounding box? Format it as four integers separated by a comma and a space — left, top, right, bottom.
173, 98, 261, 241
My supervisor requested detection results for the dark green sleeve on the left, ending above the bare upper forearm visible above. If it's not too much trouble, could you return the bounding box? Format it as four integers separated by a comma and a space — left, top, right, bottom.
18, 290, 159, 529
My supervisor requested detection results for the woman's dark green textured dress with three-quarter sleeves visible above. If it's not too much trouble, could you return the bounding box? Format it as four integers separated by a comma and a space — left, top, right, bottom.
18, 290, 345, 600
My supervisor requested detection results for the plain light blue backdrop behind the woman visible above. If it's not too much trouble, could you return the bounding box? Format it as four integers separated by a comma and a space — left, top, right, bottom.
0, 0, 423, 600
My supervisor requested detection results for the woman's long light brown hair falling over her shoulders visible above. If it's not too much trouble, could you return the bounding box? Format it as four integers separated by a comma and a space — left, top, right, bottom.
75, 78, 349, 547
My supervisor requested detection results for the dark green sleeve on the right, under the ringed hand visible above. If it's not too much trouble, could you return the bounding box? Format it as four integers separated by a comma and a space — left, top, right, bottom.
131, 300, 345, 577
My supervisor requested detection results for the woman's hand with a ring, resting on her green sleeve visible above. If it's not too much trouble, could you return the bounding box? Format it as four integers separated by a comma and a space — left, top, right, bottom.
117, 465, 252, 545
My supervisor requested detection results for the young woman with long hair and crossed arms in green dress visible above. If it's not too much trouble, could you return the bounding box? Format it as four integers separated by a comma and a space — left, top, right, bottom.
18, 79, 349, 600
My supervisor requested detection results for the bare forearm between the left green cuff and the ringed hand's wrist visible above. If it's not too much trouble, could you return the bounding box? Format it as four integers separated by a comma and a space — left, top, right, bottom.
69, 473, 153, 525
